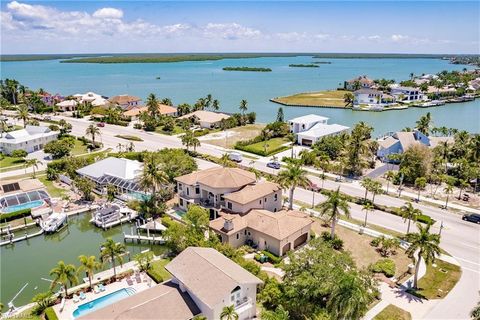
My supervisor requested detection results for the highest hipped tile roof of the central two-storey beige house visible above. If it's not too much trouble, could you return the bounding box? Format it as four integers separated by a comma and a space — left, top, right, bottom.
175, 167, 256, 188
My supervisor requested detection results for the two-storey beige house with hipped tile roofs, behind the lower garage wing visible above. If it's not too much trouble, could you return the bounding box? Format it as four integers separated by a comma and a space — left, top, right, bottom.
175, 167, 282, 219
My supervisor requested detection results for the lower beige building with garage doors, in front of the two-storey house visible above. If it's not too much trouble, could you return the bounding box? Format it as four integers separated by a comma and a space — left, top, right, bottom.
210, 209, 313, 256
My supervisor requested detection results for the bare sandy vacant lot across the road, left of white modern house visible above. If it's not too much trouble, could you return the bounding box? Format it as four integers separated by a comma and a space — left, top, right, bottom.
202, 124, 265, 149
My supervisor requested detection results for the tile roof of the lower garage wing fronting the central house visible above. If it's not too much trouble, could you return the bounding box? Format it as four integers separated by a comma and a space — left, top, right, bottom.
210, 209, 313, 240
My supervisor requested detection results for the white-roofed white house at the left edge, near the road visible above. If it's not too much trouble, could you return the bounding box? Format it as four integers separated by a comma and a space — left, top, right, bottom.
0, 126, 58, 154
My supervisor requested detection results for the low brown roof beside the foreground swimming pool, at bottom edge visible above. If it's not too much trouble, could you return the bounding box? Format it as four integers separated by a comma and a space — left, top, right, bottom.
80, 282, 200, 320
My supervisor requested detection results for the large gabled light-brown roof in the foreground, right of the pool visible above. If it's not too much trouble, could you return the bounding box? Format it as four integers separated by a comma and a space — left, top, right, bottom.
165, 247, 262, 307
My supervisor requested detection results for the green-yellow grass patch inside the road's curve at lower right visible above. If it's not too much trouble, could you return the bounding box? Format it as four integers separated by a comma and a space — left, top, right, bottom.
409, 259, 462, 299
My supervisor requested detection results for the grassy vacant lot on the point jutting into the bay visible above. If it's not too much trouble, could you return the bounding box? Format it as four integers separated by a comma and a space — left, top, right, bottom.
272, 90, 349, 108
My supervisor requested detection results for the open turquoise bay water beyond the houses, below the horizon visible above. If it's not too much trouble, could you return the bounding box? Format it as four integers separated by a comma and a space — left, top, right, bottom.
1, 56, 480, 135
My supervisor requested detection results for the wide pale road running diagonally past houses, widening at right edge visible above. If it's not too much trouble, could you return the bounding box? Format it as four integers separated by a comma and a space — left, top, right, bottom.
9, 114, 480, 319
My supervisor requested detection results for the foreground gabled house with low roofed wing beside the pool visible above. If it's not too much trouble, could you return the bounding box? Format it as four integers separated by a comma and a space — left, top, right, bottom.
82, 247, 262, 320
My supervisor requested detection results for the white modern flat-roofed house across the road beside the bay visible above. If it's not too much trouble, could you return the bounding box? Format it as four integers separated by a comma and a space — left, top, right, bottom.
288, 114, 349, 146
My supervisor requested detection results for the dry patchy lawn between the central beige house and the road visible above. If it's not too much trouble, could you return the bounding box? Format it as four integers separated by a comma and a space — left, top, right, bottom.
312, 219, 412, 277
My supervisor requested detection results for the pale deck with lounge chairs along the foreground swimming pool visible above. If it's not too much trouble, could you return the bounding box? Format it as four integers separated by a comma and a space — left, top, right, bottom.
53, 273, 156, 319
